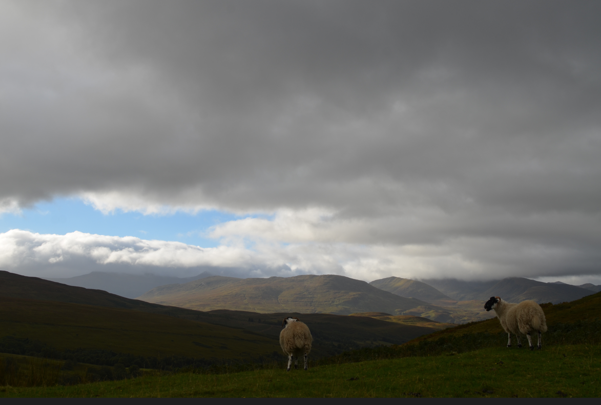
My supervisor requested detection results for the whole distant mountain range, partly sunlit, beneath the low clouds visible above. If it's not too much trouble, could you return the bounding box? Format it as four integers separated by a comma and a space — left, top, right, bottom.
34, 272, 601, 323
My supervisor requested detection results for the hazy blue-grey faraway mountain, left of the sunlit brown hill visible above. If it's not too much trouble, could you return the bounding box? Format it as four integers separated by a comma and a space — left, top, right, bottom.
46, 271, 212, 298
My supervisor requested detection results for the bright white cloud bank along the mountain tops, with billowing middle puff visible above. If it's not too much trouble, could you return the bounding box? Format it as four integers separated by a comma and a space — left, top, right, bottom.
0, 205, 601, 284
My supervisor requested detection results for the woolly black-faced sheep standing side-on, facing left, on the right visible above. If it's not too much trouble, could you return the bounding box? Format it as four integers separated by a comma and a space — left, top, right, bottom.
484, 297, 547, 350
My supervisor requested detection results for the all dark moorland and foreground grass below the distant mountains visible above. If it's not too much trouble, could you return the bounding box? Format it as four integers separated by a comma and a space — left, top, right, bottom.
0, 272, 601, 397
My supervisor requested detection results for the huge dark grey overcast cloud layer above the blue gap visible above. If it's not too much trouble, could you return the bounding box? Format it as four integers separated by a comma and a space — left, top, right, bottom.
0, 0, 601, 282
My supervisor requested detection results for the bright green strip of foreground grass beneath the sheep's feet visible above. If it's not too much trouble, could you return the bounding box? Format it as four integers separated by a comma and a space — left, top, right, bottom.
0, 344, 601, 398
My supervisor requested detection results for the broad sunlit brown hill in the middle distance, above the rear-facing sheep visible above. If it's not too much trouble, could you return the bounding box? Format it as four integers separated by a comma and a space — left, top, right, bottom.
138, 275, 446, 315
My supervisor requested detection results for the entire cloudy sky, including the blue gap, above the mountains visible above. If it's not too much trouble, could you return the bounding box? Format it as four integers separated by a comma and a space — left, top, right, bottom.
0, 0, 601, 285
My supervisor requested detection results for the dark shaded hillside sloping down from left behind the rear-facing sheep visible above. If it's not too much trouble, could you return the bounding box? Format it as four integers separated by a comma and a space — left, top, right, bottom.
0, 271, 440, 359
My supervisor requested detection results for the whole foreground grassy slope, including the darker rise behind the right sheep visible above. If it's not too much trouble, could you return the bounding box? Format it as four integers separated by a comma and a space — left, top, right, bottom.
0, 293, 601, 398
